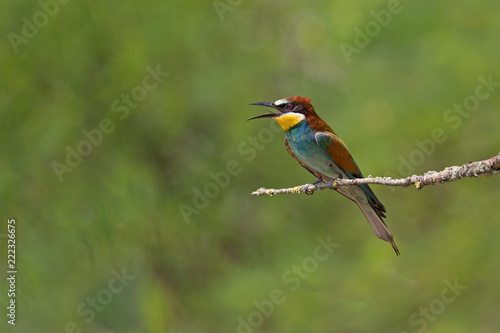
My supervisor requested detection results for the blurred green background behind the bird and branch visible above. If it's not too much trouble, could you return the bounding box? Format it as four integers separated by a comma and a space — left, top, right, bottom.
0, 0, 500, 333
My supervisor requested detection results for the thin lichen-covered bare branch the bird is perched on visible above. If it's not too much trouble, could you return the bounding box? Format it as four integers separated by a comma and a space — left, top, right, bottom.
252, 154, 500, 196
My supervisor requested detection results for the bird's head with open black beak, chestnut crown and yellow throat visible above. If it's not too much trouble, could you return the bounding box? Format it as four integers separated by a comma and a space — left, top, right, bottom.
248, 96, 318, 132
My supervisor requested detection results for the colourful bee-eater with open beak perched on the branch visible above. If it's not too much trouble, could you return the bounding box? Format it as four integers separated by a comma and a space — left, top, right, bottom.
248, 96, 400, 256
